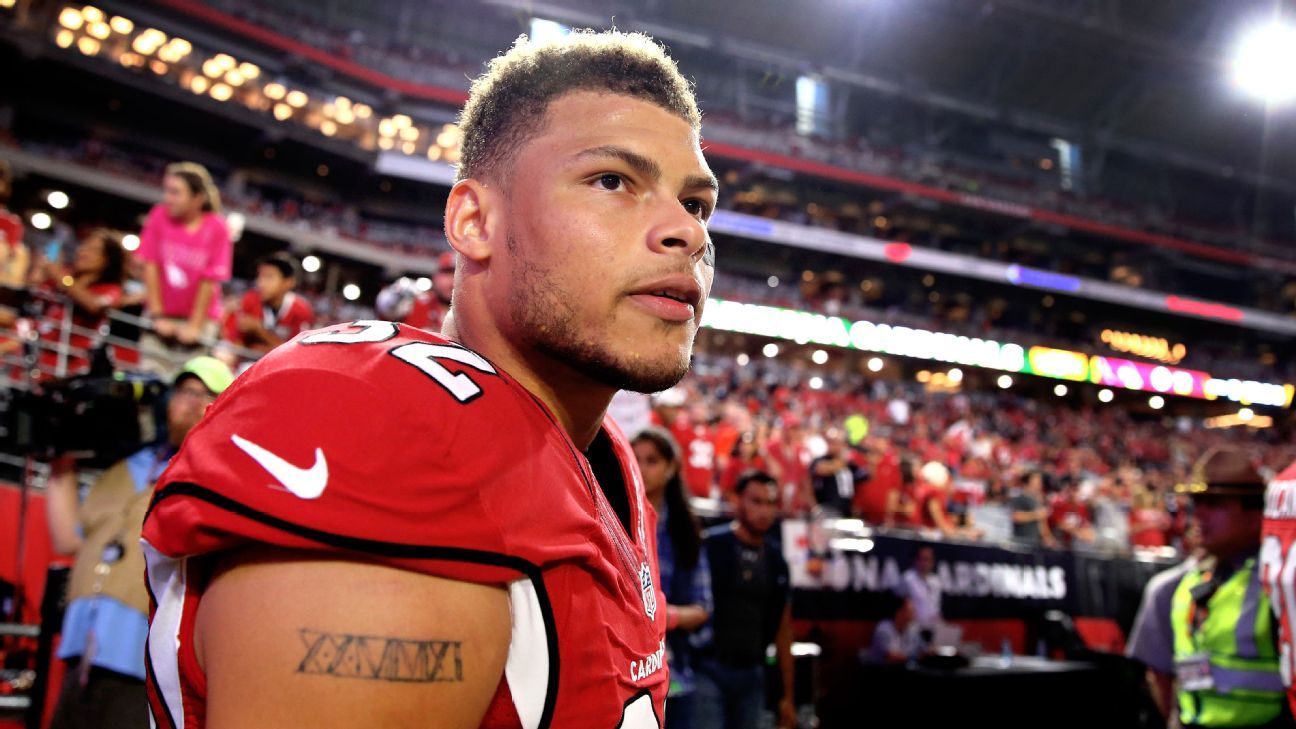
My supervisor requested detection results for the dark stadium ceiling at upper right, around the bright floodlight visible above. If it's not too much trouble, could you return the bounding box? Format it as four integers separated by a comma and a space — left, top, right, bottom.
487, 0, 1296, 192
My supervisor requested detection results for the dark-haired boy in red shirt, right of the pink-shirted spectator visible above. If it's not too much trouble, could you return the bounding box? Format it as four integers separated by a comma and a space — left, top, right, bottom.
226, 253, 315, 354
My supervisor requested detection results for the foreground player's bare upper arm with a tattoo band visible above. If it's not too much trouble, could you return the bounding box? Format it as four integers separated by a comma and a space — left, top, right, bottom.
194, 547, 511, 729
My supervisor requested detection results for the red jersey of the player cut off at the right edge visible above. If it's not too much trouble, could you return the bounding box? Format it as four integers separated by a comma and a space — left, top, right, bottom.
1260, 463, 1296, 711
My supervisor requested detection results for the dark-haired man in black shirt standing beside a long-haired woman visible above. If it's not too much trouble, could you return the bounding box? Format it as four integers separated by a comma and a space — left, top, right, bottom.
696, 471, 796, 729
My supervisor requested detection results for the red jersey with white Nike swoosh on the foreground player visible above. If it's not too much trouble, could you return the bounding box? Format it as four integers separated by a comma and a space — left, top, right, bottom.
144, 320, 669, 729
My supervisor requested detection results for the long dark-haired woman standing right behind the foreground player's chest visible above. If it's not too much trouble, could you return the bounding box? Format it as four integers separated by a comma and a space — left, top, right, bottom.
631, 427, 713, 729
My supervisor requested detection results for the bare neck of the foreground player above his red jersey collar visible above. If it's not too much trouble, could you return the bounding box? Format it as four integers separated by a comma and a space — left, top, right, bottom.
441, 309, 617, 450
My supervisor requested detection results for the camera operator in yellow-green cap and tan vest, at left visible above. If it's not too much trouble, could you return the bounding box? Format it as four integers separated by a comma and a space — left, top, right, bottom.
47, 357, 233, 729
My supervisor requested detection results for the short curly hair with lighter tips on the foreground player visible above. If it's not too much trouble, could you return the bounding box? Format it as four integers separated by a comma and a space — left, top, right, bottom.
456, 30, 701, 180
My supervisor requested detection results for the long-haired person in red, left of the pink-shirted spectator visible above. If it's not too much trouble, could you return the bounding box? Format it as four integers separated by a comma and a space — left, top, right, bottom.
23, 228, 126, 379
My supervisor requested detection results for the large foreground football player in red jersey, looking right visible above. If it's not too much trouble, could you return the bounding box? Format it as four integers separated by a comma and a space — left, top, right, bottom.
144, 31, 717, 729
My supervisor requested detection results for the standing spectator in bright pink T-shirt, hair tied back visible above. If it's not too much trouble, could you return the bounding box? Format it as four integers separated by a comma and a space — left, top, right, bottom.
136, 162, 233, 374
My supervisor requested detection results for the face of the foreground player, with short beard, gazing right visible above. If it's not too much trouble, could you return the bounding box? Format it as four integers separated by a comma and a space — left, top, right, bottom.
489, 91, 715, 392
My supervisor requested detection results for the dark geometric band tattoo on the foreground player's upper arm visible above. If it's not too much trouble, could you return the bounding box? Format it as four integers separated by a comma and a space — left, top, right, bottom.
297, 628, 464, 684
